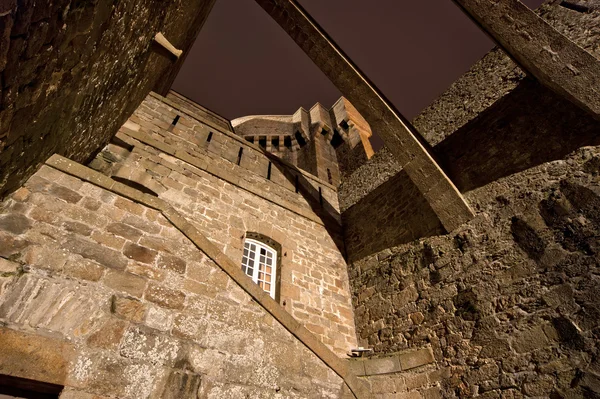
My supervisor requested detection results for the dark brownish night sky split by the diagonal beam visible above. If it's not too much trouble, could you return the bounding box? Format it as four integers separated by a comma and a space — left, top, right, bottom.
173, 0, 542, 126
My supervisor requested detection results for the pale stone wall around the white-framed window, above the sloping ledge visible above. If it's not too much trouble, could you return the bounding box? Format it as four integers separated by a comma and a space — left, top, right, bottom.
90, 95, 356, 355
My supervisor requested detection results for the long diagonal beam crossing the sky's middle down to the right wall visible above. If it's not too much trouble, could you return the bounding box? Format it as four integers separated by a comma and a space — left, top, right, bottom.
256, 0, 473, 231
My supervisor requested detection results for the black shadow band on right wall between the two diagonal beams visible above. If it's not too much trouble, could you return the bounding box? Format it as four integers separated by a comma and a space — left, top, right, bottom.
435, 79, 600, 192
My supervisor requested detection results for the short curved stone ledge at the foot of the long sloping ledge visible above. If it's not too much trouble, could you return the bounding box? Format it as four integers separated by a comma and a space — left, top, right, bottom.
348, 348, 435, 376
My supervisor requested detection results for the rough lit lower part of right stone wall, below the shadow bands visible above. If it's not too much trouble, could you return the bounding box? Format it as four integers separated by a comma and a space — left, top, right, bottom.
349, 148, 600, 398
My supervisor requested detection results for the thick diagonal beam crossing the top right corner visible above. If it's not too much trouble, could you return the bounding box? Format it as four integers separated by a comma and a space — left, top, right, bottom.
453, 0, 600, 119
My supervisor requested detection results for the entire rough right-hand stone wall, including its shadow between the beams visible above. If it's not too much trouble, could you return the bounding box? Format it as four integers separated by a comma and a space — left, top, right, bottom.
340, 2, 600, 398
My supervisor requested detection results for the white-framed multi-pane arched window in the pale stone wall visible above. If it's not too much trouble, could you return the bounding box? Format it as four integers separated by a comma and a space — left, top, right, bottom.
242, 238, 277, 299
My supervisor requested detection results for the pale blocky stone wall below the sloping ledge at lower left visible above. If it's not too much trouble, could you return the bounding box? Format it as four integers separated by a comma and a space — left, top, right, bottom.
0, 166, 343, 399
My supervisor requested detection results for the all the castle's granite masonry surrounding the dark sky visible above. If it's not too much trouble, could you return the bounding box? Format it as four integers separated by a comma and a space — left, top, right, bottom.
0, 0, 600, 399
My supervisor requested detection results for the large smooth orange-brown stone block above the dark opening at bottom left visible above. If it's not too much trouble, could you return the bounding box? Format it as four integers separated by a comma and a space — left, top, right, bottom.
0, 328, 75, 385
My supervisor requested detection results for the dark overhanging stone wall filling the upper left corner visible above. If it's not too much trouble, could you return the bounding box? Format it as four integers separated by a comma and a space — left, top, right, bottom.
0, 0, 214, 198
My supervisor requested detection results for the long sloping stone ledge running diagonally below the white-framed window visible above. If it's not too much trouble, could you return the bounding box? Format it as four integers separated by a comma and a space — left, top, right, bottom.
46, 155, 372, 399
